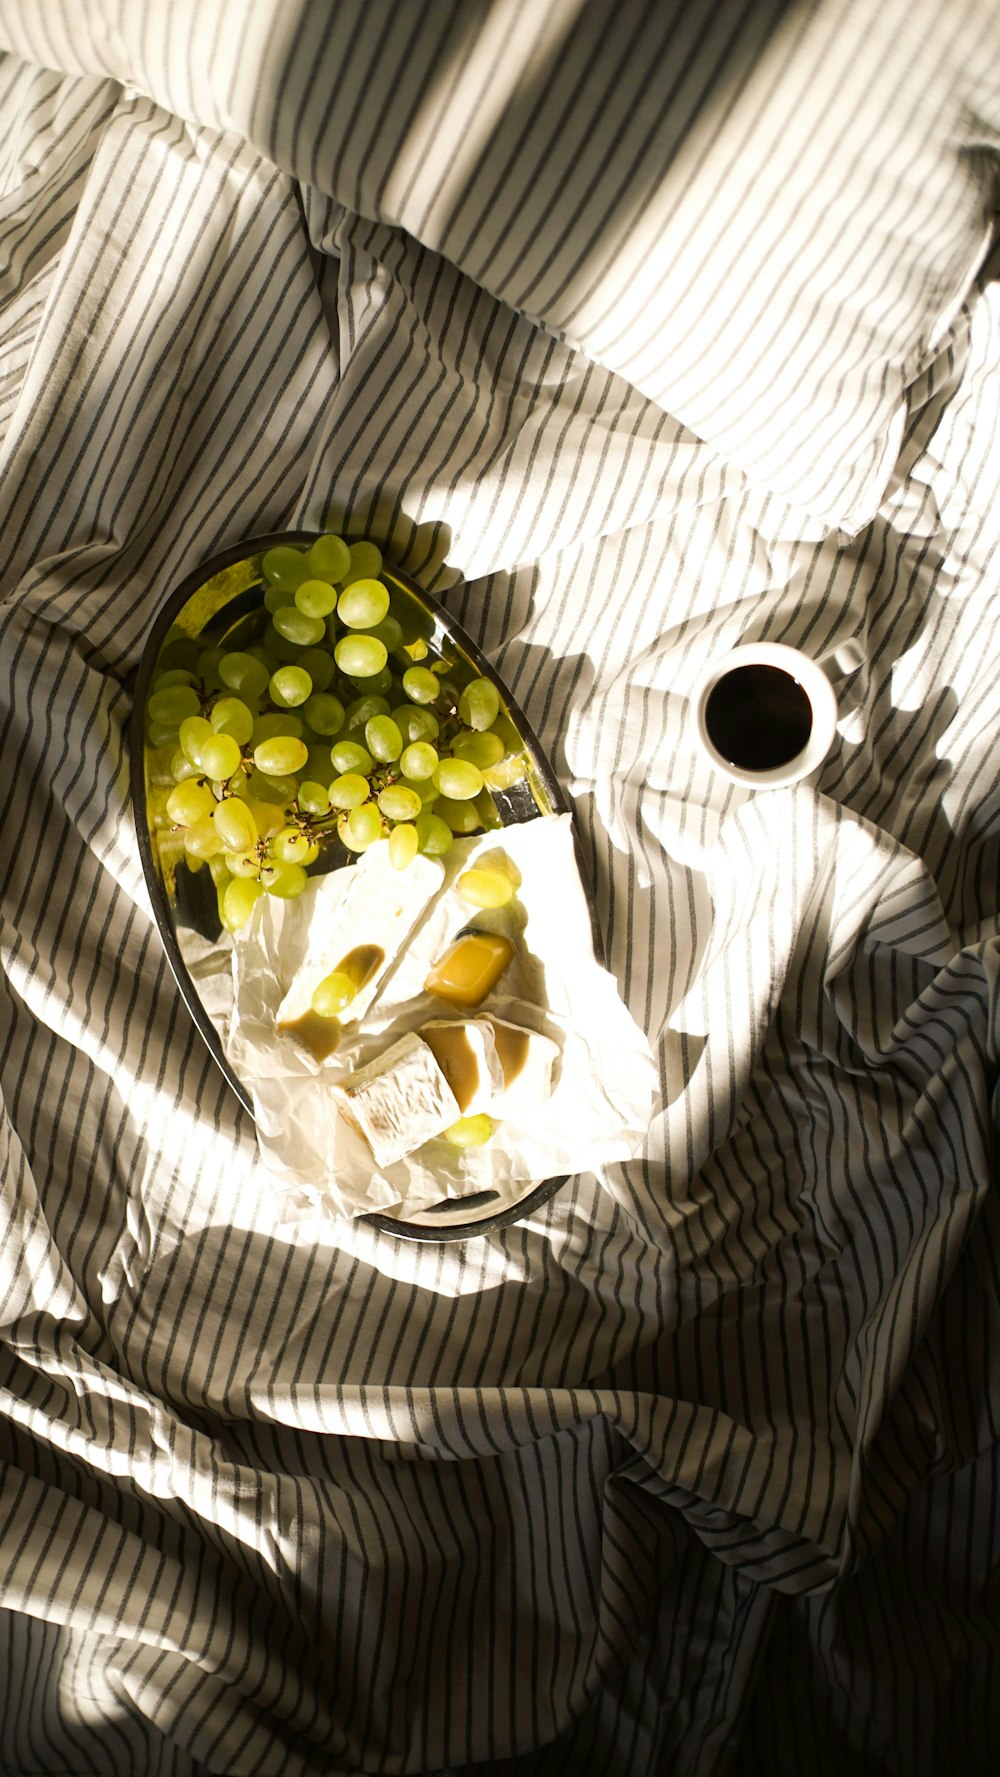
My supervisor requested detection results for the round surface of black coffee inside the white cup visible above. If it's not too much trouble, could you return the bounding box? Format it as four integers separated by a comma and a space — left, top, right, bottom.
705, 666, 812, 771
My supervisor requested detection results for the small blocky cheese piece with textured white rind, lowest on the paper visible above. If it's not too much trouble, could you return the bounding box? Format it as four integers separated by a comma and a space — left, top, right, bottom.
334, 1032, 460, 1166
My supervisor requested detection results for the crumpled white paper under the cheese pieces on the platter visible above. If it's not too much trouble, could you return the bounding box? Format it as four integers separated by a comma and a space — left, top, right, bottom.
226, 816, 659, 1217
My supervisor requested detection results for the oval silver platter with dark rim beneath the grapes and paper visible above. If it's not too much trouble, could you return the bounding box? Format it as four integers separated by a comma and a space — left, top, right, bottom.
130, 531, 602, 1240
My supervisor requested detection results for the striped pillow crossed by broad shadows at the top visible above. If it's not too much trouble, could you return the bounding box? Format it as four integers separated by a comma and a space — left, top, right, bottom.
0, 0, 1000, 531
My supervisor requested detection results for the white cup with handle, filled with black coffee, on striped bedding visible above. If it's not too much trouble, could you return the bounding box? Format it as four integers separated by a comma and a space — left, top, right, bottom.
691, 640, 863, 789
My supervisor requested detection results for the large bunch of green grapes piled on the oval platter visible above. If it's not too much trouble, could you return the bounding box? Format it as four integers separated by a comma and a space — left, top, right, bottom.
146, 535, 508, 931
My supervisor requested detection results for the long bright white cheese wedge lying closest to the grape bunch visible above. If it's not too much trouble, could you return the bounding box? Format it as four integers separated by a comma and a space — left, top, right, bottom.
277, 842, 444, 1029
